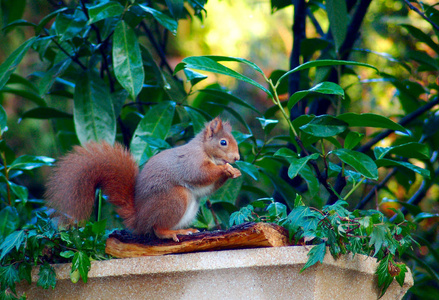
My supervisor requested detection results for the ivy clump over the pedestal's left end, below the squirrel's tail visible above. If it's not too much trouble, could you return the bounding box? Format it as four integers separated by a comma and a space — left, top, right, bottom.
0, 213, 109, 299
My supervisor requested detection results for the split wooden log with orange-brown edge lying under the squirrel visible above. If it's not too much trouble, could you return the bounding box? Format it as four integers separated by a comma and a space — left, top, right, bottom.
105, 223, 290, 258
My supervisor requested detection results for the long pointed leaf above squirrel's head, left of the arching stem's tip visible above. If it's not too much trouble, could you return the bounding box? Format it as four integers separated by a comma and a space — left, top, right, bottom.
174, 56, 273, 97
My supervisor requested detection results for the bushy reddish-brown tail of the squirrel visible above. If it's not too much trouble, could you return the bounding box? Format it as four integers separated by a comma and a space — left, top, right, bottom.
46, 142, 139, 228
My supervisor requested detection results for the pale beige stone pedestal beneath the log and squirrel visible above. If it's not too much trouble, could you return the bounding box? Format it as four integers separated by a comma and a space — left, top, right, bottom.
18, 246, 413, 300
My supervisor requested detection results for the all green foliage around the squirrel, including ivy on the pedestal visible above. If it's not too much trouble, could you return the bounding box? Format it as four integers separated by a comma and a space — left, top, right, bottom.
0, 0, 439, 297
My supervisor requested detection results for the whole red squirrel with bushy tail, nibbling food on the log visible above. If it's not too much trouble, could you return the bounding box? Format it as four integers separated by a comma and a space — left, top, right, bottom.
46, 117, 241, 242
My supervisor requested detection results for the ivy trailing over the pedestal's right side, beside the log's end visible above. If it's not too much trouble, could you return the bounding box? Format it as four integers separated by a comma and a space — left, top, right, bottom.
230, 196, 417, 296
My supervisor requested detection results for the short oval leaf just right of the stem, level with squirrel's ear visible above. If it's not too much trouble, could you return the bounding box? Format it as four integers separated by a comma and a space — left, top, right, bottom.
299, 115, 348, 137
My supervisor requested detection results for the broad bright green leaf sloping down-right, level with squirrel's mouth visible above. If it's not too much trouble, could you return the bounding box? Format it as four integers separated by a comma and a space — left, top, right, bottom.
330, 149, 378, 179
